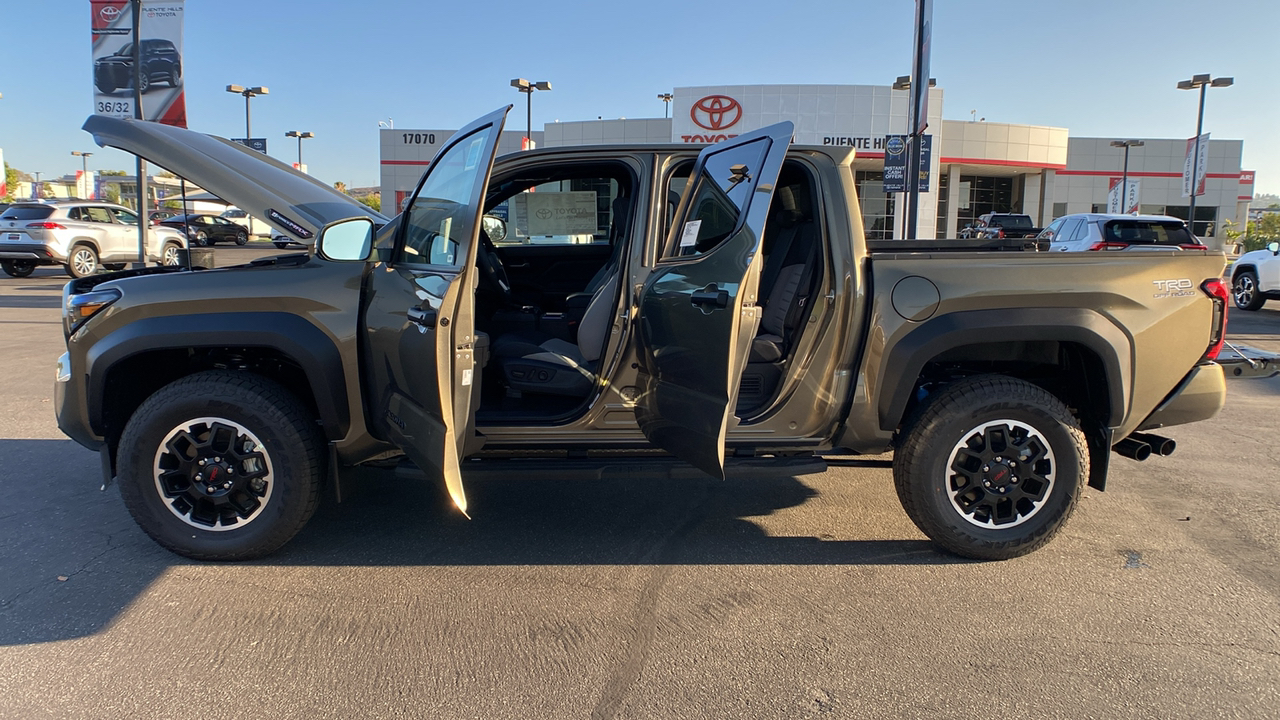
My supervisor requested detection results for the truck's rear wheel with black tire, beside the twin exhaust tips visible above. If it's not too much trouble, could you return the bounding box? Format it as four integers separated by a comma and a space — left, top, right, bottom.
893, 375, 1089, 560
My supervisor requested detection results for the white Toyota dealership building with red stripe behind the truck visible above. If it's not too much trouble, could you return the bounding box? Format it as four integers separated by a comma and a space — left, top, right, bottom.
380, 85, 1253, 240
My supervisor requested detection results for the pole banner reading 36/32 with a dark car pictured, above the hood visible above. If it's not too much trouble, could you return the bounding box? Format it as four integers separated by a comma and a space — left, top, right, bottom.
90, 0, 187, 128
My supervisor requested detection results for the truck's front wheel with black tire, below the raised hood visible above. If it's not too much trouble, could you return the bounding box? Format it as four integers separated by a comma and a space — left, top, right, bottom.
116, 370, 324, 560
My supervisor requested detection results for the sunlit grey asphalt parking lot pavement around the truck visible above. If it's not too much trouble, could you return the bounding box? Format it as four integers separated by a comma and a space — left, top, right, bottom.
0, 245, 1280, 719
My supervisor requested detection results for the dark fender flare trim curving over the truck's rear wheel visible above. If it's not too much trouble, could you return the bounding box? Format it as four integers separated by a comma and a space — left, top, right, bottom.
877, 307, 1133, 432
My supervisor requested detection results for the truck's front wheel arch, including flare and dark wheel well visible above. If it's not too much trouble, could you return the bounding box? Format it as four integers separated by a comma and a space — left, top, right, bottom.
86, 313, 351, 448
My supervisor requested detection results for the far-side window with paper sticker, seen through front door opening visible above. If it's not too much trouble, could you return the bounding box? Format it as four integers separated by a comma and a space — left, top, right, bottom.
486, 177, 631, 246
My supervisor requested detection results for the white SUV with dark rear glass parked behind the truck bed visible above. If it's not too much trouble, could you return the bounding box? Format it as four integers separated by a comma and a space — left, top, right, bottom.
1037, 213, 1206, 252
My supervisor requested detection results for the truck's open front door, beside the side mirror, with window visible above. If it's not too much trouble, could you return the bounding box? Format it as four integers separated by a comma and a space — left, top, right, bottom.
365, 105, 511, 514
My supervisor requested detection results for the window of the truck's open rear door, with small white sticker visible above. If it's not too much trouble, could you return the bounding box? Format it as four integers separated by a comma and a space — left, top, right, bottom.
663, 138, 769, 259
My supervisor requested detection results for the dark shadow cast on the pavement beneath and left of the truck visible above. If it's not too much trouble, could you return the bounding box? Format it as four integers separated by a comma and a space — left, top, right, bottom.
0, 439, 969, 646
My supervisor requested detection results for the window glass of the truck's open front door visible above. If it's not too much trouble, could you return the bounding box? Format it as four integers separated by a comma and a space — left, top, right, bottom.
404, 126, 493, 266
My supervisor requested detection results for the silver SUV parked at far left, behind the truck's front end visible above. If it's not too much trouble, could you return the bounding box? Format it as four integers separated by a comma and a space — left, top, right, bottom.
0, 200, 187, 278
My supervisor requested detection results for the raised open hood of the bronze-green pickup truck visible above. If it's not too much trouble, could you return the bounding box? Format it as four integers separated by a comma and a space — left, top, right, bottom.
83, 115, 388, 242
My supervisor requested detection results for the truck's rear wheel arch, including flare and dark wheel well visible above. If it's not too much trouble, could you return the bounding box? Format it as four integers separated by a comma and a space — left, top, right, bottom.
877, 307, 1133, 430
